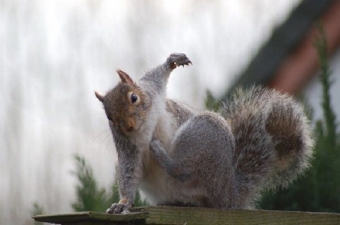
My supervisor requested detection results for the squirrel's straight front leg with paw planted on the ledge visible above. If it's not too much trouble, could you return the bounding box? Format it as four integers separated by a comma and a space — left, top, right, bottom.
106, 127, 140, 214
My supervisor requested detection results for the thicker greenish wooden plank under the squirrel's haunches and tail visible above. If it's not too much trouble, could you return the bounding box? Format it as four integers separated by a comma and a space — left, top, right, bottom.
146, 207, 340, 225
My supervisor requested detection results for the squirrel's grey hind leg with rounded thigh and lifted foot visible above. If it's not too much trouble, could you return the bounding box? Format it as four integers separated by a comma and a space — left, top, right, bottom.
150, 112, 238, 208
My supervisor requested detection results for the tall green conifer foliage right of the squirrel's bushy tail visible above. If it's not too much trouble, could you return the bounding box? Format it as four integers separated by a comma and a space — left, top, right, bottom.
260, 25, 340, 212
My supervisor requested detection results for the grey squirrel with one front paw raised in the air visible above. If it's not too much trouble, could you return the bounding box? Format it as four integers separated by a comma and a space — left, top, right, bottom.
95, 53, 313, 214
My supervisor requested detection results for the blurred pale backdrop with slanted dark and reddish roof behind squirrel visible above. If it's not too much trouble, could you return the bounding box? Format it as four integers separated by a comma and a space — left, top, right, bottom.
0, 0, 340, 224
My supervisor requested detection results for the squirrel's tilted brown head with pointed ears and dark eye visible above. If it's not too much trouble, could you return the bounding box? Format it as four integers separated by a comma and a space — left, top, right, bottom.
95, 70, 151, 135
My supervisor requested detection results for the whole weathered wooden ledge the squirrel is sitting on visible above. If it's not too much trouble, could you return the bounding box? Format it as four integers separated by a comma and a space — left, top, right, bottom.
33, 206, 340, 225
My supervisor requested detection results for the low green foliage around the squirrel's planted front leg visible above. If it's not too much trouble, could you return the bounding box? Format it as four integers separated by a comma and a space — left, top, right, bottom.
72, 155, 146, 212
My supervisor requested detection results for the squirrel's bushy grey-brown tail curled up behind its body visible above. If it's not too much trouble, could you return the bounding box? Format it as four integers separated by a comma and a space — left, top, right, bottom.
221, 87, 313, 205
